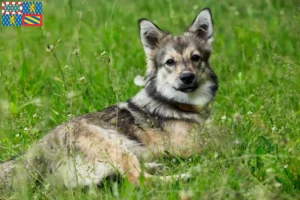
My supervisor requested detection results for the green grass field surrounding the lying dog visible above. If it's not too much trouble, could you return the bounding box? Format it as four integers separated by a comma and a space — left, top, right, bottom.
0, 0, 300, 200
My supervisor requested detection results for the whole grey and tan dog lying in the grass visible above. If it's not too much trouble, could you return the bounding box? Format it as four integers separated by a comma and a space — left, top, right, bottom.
0, 8, 218, 188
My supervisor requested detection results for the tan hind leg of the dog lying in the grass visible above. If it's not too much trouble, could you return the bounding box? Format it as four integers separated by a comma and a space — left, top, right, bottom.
75, 125, 190, 185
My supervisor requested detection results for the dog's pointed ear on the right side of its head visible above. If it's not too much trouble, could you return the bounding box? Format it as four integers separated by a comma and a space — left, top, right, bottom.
187, 8, 213, 41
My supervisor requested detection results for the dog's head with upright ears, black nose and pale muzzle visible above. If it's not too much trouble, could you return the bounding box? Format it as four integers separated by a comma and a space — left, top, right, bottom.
139, 8, 218, 106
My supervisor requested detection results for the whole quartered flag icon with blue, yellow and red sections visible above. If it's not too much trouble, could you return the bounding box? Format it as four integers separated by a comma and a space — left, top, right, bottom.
1, 2, 43, 26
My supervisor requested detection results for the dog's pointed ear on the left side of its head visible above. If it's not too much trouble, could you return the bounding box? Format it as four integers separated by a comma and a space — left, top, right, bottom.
138, 19, 166, 53
